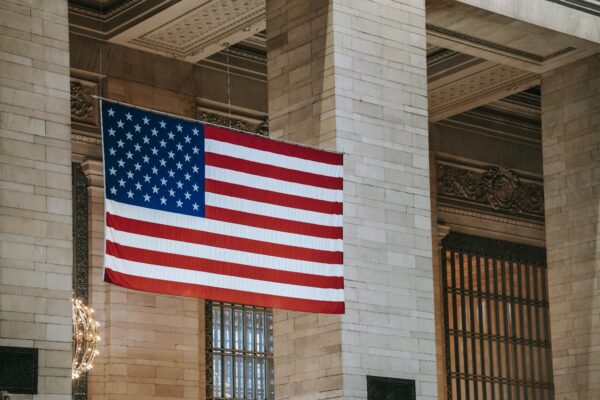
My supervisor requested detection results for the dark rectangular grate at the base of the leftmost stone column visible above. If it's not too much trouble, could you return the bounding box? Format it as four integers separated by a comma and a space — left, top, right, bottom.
0, 346, 38, 394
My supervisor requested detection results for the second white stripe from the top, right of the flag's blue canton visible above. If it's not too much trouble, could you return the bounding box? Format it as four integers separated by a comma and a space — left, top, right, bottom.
205, 165, 344, 202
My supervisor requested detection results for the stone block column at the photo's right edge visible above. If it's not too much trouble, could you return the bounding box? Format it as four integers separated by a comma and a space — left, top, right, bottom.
542, 55, 600, 400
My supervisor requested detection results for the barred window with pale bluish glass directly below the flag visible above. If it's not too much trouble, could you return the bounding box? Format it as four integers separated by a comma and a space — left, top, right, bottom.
206, 302, 275, 400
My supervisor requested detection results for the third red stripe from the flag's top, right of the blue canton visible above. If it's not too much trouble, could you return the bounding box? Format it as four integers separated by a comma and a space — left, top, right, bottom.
204, 179, 343, 215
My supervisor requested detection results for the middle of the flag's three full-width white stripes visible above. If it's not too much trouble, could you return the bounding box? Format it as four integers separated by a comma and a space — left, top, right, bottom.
105, 227, 343, 276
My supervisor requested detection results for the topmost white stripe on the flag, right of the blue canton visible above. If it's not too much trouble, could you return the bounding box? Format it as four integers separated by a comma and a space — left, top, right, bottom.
204, 139, 344, 178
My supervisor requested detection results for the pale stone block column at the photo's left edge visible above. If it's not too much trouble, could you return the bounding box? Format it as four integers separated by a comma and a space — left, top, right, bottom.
0, 0, 73, 400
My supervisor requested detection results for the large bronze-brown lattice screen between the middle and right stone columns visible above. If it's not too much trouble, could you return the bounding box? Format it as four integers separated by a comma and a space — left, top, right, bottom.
441, 233, 554, 400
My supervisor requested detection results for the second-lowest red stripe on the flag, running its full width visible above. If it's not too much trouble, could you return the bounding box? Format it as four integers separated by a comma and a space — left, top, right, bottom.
106, 240, 344, 289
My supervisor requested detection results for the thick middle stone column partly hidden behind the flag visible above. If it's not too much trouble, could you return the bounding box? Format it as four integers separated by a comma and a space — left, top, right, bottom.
267, 0, 437, 400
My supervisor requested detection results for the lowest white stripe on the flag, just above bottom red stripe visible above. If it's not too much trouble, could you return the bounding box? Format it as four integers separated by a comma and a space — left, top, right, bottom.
105, 255, 344, 301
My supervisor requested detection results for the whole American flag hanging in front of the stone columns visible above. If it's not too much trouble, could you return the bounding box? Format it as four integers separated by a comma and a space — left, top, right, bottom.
101, 100, 344, 313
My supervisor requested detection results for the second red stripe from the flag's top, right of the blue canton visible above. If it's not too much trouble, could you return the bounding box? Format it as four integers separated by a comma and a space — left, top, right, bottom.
204, 152, 344, 190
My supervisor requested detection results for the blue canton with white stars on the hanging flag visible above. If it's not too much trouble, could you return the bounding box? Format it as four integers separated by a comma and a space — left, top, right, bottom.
102, 102, 205, 217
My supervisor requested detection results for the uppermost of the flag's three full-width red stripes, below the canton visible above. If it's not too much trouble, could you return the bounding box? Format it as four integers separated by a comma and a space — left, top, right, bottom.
106, 213, 343, 264
